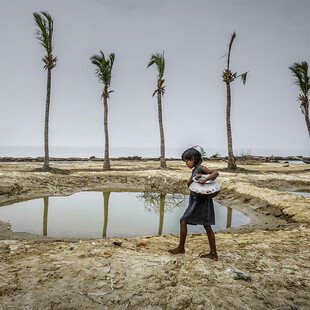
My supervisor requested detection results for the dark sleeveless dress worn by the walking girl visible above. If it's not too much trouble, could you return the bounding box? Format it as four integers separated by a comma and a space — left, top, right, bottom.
180, 165, 215, 226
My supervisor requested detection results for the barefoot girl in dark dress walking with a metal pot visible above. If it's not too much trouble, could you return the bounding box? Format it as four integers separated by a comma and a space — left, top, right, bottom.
169, 148, 219, 260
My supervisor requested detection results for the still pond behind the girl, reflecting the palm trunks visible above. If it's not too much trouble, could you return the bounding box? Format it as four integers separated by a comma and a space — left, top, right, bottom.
0, 191, 250, 238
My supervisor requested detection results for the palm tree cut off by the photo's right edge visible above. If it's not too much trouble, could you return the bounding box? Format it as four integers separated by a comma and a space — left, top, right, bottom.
289, 61, 310, 137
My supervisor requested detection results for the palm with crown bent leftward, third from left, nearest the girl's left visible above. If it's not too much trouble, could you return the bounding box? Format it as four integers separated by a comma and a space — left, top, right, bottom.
147, 52, 167, 168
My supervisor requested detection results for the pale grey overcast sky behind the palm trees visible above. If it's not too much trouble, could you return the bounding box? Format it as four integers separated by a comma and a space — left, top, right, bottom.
0, 0, 310, 156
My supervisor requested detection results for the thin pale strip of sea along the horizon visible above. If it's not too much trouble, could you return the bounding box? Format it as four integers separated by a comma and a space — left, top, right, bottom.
0, 146, 310, 158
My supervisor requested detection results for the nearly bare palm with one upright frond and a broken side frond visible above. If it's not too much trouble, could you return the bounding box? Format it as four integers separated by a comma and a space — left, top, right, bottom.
222, 32, 248, 170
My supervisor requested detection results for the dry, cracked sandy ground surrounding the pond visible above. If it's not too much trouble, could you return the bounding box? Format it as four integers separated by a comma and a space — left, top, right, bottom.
0, 161, 310, 309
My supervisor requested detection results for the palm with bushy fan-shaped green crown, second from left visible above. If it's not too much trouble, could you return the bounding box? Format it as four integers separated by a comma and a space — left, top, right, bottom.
90, 51, 115, 170
